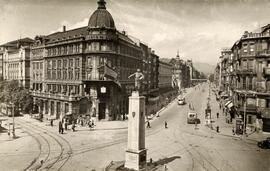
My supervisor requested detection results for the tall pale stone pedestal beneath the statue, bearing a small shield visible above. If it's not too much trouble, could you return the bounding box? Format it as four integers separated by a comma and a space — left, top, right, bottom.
125, 91, 146, 170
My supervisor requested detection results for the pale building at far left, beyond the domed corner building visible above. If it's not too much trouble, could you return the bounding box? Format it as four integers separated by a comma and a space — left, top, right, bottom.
0, 38, 33, 88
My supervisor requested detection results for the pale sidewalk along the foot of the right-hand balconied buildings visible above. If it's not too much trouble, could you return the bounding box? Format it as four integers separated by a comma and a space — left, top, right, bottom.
205, 91, 270, 142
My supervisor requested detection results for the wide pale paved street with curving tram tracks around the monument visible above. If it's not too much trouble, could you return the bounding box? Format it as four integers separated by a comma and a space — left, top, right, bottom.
0, 83, 270, 171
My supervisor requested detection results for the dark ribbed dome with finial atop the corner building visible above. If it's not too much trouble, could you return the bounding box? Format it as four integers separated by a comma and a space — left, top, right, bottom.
88, 0, 115, 30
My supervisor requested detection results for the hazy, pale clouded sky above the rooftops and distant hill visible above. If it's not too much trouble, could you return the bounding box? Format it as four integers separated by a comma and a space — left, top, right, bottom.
0, 0, 270, 65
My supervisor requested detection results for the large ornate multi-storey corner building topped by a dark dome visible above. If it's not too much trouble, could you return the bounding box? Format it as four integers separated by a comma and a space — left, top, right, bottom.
30, 0, 159, 120
